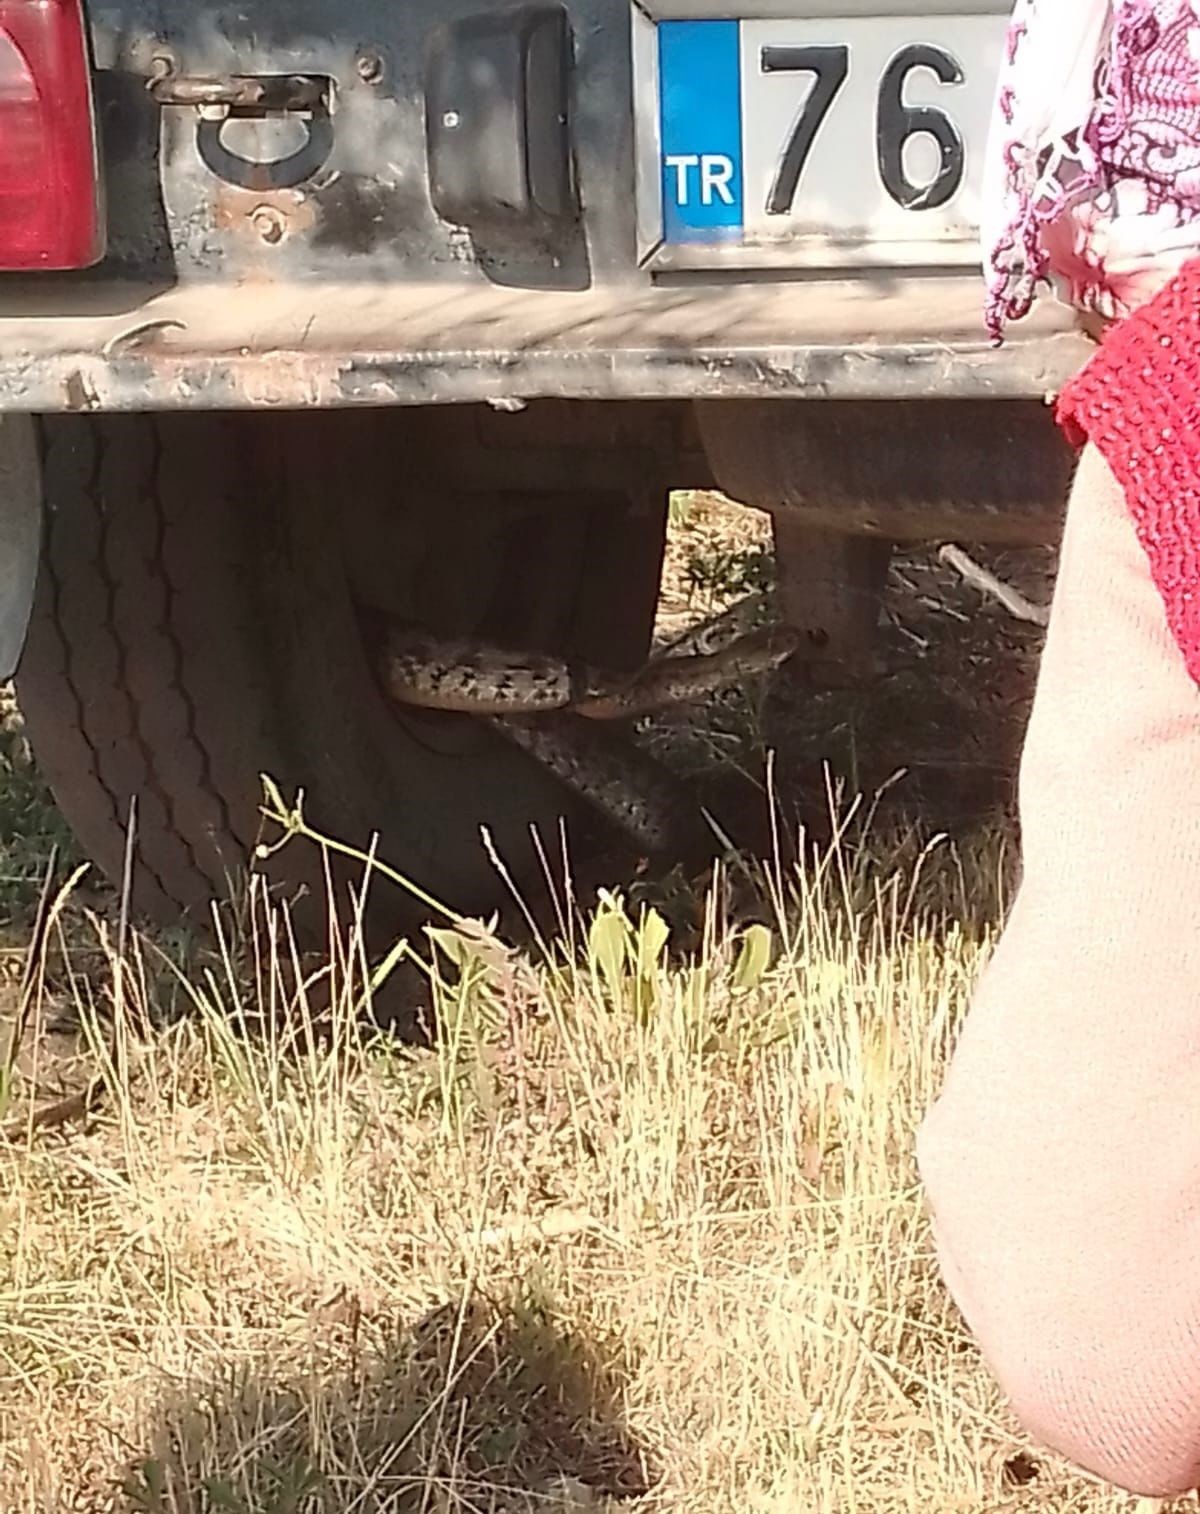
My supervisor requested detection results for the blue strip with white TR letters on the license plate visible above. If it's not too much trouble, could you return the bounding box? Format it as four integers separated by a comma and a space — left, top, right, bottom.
658, 21, 745, 242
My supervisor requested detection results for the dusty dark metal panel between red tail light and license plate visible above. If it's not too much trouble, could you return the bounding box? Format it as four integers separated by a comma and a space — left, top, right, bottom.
71, 0, 636, 289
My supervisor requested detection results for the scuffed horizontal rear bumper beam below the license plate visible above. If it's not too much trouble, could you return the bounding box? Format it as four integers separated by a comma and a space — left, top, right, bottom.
0, 276, 1090, 412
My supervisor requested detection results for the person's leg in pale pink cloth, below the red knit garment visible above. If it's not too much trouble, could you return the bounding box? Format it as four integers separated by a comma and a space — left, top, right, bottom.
917, 447, 1200, 1494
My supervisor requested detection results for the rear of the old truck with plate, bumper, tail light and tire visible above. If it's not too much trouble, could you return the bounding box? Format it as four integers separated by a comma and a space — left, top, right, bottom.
0, 0, 1083, 930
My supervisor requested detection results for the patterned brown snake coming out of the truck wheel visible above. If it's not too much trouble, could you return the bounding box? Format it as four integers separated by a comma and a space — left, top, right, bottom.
380, 625, 799, 855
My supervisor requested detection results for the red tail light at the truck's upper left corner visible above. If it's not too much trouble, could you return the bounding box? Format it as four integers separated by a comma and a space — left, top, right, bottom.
0, 0, 104, 269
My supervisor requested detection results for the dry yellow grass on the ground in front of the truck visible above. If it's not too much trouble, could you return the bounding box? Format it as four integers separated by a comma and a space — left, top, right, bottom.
0, 793, 1168, 1514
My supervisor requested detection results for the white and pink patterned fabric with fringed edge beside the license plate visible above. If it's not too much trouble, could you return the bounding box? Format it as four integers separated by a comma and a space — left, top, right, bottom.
984, 0, 1200, 341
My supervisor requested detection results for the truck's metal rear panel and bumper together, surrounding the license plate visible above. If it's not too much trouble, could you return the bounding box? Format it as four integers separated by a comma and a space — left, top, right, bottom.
0, 0, 1087, 412
